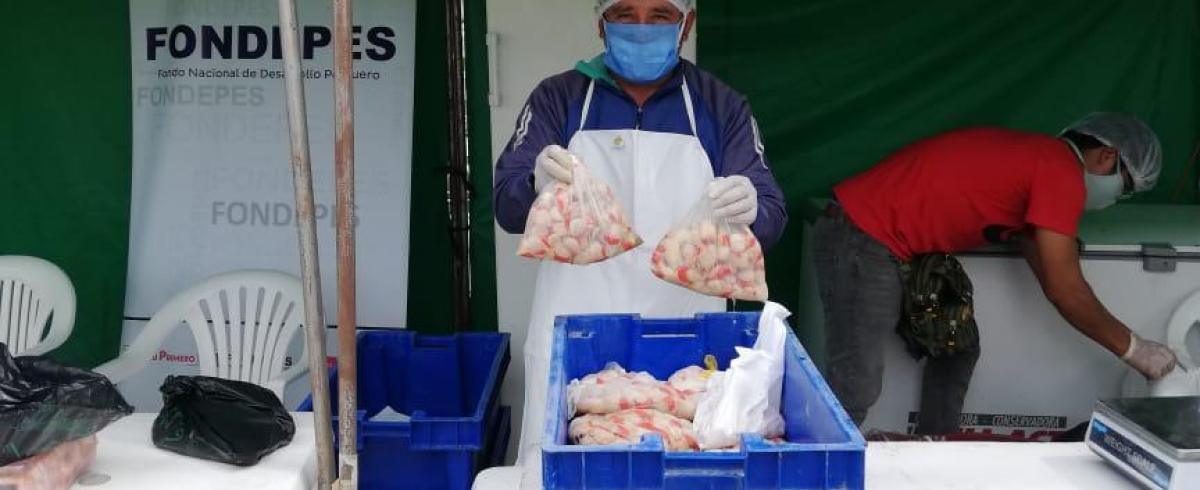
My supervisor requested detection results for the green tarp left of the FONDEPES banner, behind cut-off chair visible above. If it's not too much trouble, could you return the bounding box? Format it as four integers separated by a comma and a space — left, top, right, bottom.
0, 1, 133, 366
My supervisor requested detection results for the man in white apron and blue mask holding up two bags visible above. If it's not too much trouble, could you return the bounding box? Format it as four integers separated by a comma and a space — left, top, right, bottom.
493, 0, 787, 488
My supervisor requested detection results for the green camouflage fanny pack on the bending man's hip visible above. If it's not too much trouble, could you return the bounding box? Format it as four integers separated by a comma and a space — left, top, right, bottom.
896, 253, 979, 360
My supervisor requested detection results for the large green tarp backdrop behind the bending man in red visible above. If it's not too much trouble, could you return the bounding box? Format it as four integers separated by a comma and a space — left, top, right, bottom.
698, 0, 1200, 317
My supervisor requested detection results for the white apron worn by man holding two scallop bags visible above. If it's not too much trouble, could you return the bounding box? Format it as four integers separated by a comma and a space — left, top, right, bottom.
517, 80, 725, 489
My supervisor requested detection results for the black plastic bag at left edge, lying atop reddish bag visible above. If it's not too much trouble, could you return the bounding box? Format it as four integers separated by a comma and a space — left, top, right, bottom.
0, 343, 133, 466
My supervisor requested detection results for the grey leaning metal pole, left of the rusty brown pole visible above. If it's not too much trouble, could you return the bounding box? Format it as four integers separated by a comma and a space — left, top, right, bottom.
278, 0, 338, 490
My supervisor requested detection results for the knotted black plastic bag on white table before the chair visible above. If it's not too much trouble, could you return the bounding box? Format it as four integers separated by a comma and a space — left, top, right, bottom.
152, 376, 295, 466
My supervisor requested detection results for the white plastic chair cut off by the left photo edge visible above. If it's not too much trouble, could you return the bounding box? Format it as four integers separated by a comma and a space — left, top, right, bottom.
0, 256, 76, 355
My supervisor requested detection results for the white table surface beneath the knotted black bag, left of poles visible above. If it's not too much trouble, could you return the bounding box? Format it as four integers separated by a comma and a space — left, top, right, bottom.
83, 413, 317, 490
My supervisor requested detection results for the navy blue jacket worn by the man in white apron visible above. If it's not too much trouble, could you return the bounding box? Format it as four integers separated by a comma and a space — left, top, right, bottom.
492, 56, 787, 247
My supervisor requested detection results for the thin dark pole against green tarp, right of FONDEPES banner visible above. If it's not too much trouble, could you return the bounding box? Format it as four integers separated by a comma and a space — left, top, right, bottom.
445, 0, 470, 330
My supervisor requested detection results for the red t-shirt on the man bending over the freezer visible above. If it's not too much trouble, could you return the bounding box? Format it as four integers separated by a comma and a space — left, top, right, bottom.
834, 127, 1086, 261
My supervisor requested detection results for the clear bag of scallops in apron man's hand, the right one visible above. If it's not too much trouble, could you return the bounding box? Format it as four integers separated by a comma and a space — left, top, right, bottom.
650, 197, 767, 301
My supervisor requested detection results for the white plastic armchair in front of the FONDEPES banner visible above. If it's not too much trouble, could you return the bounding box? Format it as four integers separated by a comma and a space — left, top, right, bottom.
96, 270, 308, 400
